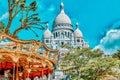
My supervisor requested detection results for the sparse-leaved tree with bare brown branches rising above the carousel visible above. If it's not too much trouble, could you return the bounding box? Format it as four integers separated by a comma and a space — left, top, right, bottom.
5, 0, 47, 37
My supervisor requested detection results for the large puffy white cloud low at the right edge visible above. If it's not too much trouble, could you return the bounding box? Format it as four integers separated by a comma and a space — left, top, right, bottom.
94, 29, 120, 54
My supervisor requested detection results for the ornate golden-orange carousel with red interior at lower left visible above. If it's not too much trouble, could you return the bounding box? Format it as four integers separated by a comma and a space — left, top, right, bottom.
0, 26, 59, 80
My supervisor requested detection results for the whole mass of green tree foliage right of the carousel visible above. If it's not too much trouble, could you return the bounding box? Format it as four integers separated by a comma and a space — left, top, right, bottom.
63, 48, 120, 80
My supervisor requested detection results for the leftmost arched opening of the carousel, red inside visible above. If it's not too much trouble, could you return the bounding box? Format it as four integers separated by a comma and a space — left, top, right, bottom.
0, 55, 14, 79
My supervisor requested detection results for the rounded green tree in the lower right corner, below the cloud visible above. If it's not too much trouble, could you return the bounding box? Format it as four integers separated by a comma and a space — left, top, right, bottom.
80, 57, 120, 80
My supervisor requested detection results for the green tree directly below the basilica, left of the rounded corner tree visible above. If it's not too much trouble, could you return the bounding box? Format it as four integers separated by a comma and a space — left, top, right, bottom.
63, 48, 91, 79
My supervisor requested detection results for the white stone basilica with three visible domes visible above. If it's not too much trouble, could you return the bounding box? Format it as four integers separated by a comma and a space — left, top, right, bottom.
43, 3, 89, 50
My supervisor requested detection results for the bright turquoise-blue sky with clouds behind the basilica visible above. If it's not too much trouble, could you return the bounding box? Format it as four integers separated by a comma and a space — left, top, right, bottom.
0, 0, 120, 52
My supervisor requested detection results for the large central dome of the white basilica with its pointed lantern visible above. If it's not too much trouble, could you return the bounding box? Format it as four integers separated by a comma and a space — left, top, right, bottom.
54, 3, 71, 25
